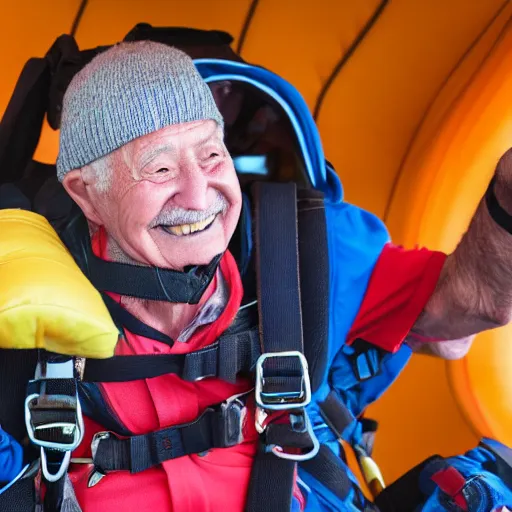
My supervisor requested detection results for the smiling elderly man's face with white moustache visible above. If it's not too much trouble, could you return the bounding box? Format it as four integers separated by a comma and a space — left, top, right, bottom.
63, 120, 242, 270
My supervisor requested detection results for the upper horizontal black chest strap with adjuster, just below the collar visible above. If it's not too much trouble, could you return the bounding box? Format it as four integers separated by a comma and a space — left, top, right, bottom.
82, 329, 260, 382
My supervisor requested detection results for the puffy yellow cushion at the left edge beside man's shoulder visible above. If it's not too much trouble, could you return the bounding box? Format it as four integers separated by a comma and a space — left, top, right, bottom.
0, 210, 118, 358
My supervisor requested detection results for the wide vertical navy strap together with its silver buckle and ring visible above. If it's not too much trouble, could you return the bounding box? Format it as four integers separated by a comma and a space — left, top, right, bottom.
246, 183, 319, 512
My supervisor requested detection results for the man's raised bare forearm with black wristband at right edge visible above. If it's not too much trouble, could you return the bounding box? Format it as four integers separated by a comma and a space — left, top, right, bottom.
413, 152, 512, 340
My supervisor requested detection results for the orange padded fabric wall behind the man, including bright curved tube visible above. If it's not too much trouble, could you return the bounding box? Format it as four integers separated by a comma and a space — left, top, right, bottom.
0, 0, 512, 481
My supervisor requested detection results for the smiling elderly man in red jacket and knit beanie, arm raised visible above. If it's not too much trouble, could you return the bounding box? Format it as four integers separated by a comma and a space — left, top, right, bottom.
1, 38, 512, 512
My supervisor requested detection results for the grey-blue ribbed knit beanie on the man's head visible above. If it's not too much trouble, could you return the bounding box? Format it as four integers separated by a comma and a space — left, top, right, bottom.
57, 41, 223, 181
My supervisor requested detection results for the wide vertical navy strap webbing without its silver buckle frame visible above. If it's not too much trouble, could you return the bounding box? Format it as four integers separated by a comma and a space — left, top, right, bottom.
246, 183, 309, 512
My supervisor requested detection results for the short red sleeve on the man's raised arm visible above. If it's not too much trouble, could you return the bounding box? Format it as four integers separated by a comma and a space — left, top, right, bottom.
347, 244, 446, 352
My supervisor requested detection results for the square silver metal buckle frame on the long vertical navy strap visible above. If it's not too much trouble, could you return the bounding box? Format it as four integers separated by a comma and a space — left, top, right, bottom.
254, 350, 311, 411
